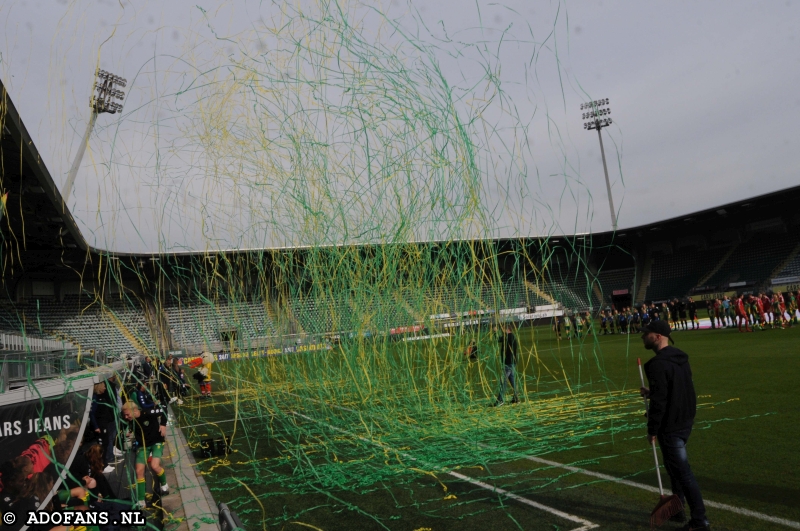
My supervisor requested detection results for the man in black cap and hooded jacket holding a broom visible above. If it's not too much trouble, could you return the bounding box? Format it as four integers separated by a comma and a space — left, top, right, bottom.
641, 321, 710, 531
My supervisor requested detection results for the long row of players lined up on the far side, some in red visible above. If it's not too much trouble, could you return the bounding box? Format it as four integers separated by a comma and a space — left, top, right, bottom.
554, 291, 800, 339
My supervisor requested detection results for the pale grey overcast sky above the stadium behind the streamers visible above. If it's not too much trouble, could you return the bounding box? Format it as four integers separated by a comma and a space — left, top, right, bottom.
0, 0, 800, 251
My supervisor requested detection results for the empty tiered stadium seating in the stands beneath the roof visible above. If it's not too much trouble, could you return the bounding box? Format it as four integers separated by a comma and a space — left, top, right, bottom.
7, 238, 800, 354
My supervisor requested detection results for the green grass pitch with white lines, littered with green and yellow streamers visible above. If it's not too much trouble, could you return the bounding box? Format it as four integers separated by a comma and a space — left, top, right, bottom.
176, 327, 800, 530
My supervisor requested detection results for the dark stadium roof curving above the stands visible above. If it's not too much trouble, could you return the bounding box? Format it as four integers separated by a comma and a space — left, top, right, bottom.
0, 81, 800, 276
